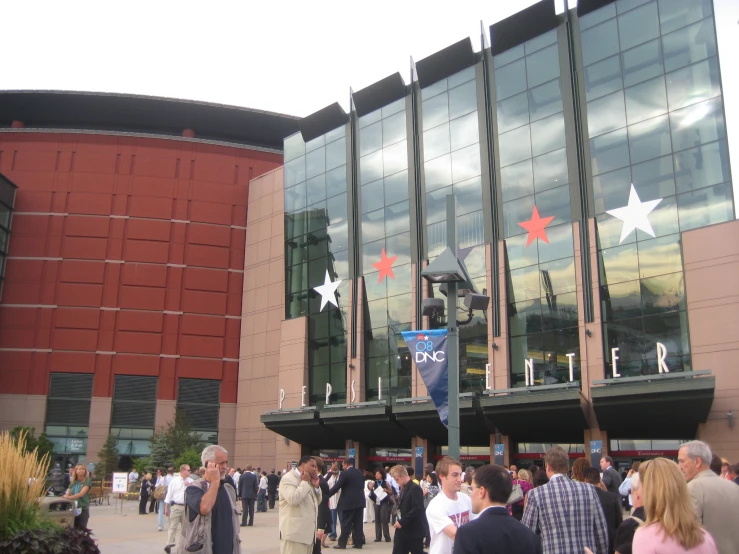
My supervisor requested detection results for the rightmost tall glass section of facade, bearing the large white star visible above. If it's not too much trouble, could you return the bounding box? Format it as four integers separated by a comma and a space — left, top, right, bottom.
581, 0, 734, 376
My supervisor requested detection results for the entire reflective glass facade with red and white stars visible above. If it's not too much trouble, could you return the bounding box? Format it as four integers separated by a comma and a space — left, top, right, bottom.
285, 0, 734, 406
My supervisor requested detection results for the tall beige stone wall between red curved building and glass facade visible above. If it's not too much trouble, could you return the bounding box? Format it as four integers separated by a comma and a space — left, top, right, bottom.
237, 168, 300, 468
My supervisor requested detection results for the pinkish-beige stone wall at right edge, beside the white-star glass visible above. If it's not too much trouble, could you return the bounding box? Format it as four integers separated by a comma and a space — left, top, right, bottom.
683, 221, 739, 462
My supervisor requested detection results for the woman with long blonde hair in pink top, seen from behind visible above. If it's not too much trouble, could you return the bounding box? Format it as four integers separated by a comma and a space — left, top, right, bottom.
632, 458, 718, 554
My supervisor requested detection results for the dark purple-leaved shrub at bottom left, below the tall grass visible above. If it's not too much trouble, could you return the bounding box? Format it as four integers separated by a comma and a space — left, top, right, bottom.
0, 526, 100, 554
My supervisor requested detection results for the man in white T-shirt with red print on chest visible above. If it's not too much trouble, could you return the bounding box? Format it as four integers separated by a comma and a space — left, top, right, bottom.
426, 456, 476, 554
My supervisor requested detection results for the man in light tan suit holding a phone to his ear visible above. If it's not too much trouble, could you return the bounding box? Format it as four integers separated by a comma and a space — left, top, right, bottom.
280, 456, 321, 554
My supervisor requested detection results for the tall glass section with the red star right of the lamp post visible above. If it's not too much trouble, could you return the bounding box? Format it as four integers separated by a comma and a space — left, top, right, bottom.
494, 30, 580, 387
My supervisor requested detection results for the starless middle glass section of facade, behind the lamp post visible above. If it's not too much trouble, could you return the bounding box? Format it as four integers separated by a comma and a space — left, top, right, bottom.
421, 66, 488, 392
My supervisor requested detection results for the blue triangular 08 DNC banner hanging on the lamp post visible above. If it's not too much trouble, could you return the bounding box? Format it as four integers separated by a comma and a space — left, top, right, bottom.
402, 329, 449, 426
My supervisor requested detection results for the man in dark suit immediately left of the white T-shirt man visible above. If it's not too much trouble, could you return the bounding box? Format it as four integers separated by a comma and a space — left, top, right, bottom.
390, 466, 426, 554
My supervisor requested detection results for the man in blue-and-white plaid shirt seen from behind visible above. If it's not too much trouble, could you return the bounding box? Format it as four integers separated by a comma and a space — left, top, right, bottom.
521, 446, 608, 554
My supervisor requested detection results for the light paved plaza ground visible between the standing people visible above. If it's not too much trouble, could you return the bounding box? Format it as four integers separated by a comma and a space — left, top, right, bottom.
89, 499, 393, 554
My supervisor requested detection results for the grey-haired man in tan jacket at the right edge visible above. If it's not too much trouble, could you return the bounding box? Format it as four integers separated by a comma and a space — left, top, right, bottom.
677, 441, 739, 554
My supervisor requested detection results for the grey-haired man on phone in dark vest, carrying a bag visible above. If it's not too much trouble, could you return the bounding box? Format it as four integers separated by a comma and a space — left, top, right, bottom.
177, 444, 241, 554
